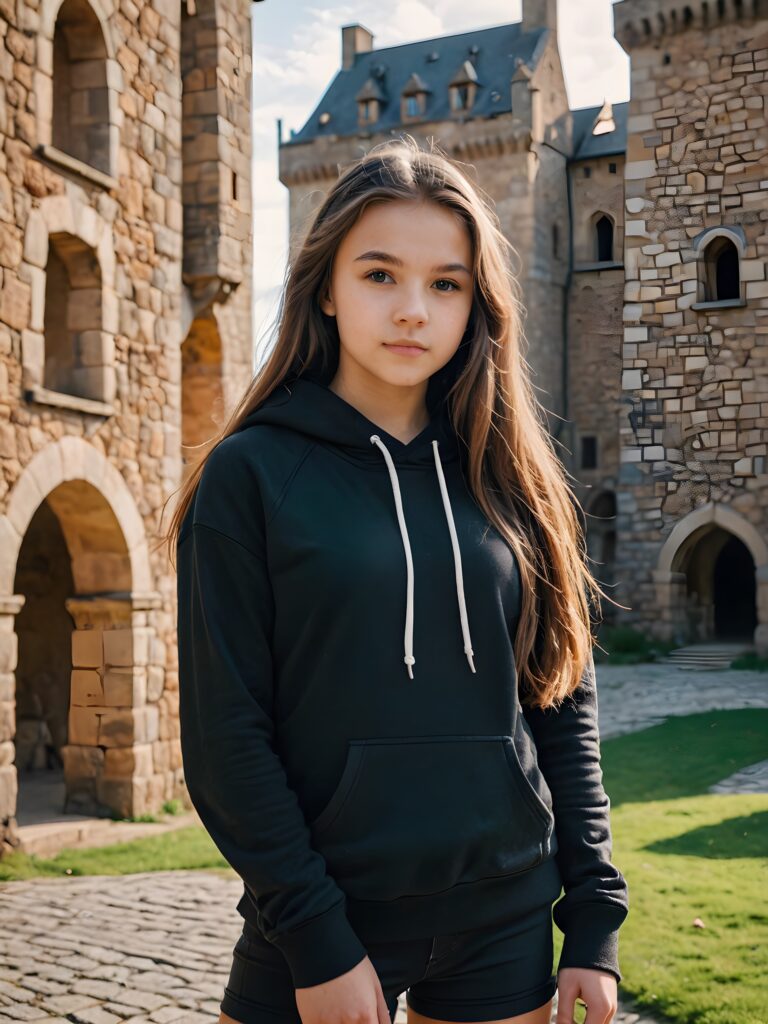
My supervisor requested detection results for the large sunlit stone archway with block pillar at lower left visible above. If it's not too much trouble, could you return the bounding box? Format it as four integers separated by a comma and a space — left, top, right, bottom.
0, 436, 165, 847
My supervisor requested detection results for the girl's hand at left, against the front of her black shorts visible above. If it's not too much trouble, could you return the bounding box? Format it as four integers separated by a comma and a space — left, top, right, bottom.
295, 956, 391, 1024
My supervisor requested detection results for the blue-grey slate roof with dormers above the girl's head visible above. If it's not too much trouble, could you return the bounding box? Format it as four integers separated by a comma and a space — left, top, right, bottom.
284, 22, 546, 145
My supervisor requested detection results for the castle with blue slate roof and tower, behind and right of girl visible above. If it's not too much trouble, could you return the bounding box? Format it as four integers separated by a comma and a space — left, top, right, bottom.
280, 0, 768, 653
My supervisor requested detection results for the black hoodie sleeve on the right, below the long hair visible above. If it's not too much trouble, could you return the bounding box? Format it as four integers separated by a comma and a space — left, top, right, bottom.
523, 653, 629, 981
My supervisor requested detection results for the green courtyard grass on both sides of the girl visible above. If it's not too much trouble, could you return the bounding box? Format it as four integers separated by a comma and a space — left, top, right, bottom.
0, 709, 768, 1024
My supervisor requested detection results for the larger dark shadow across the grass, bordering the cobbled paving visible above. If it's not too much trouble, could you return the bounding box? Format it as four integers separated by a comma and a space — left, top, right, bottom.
600, 708, 768, 806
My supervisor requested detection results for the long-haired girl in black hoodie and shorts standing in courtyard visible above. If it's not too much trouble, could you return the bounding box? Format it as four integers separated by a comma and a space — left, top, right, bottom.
168, 137, 629, 1024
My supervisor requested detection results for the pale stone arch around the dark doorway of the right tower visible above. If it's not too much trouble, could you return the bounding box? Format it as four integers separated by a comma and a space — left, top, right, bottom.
653, 502, 768, 653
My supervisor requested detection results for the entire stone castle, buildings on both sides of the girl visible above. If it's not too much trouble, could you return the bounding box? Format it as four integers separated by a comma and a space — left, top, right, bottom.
0, 0, 768, 850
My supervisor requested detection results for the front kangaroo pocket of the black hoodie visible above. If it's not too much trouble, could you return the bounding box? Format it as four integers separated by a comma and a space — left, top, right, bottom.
310, 736, 554, 900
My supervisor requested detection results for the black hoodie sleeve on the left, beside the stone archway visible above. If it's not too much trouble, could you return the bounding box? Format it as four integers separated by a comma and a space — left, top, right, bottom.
177, 435, 367, 988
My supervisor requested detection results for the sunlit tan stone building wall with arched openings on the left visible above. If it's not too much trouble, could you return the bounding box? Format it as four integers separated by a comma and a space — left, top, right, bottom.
0, 0, 257, 848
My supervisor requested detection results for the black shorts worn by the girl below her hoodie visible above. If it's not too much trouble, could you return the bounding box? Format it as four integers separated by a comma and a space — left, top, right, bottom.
221, 903, 557, 1024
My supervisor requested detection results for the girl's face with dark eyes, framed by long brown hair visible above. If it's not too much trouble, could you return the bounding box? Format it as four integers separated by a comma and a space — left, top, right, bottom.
321, 200, 473, 387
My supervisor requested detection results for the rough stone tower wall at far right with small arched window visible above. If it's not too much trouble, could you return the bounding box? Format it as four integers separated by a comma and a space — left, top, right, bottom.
614, 0, 768, 651
